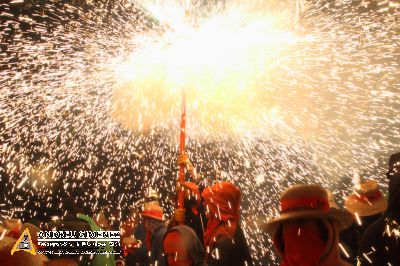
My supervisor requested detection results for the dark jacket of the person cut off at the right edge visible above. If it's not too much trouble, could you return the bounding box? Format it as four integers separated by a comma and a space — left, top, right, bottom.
359, 176, 400, 266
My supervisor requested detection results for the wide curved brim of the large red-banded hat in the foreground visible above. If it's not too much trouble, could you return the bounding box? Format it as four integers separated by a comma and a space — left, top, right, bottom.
262, 208, 353, 237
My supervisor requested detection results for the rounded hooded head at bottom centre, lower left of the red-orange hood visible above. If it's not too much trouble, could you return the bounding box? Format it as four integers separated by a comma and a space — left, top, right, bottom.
163, 225, 205, 266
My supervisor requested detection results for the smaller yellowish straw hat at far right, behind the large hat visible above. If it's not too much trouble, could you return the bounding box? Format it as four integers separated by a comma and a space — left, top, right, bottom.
344, 179, 387, 216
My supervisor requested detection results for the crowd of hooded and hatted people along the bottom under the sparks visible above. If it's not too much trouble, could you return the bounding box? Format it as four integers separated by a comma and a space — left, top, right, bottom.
0, 153, 400, 266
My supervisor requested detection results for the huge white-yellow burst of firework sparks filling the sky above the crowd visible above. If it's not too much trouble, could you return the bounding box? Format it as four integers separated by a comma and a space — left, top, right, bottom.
0, 0, 400, 262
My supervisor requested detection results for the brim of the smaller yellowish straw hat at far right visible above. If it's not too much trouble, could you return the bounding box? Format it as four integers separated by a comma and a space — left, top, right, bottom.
344, 195, 387, 216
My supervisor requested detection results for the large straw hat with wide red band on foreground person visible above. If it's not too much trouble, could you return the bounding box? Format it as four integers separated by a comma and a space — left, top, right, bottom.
263, 184, 353, 236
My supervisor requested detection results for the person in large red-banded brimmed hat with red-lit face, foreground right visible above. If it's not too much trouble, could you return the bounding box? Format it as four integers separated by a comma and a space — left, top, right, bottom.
264, 185, 352, 266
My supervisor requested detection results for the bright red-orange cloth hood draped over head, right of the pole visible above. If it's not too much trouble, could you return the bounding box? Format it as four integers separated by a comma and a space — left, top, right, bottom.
201, 182, 240, 246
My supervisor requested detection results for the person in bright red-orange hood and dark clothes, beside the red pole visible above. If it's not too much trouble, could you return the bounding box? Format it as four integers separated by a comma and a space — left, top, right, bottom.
202, 182, 253, 266
